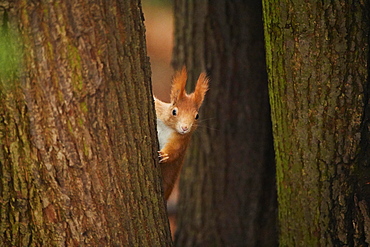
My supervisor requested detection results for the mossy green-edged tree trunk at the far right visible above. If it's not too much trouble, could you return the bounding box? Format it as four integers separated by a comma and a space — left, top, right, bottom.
264, 0, 370, 246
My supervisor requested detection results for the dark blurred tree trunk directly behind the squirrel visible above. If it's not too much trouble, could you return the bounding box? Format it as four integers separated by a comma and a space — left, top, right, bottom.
174, 0, 277, 246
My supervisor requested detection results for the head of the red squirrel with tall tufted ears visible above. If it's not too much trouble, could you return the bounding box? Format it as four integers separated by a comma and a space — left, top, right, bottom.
167, 67, 209, 134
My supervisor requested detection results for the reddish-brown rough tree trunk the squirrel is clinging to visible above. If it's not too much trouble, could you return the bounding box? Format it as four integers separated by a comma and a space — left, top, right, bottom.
0, 0, 171, 246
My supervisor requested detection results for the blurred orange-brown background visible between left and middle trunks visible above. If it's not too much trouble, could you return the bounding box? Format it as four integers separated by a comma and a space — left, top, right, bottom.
142, 0, 178, 235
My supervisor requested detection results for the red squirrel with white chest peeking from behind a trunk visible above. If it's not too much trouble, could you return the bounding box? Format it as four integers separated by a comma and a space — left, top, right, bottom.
154, 67, 209, 200
